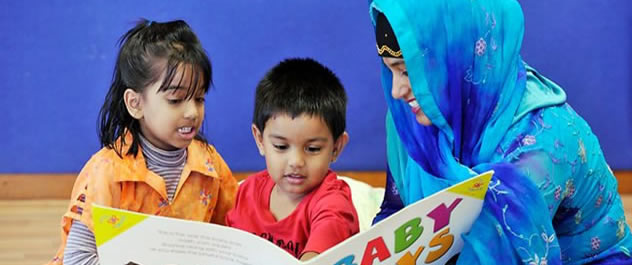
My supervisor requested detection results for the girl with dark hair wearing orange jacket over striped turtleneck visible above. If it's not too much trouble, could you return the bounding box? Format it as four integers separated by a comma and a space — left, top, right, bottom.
50, 20, 237, 265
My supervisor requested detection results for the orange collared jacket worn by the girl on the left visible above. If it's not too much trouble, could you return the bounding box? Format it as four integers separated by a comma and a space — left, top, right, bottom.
48, 138, 237, 264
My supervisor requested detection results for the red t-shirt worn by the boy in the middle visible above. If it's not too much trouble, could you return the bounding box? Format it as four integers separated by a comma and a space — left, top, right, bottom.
226, 170, 360, 258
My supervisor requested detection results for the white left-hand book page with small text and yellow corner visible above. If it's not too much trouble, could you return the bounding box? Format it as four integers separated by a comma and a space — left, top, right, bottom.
93, 204, 299, 265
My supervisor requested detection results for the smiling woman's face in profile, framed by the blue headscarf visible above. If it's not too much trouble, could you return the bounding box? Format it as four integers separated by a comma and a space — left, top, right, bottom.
382, 57, 432, 126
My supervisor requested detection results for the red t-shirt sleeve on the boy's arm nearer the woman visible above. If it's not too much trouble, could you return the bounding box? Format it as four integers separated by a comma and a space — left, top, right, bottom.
301, 184, 360, 255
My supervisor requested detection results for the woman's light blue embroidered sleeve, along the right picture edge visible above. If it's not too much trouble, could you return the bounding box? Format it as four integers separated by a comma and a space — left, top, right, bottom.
507, 105, 632, 264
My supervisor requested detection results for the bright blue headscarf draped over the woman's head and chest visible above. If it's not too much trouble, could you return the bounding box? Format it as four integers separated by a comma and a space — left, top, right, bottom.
370, 0, 566, 264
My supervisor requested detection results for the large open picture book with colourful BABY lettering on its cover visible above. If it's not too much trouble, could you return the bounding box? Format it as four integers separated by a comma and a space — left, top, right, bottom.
93, 171, 493, 265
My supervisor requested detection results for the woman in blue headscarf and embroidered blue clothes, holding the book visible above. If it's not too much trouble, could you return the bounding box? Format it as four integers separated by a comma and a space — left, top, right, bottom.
370, 0, 632, 265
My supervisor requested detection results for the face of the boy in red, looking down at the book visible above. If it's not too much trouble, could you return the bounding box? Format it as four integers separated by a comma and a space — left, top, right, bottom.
252, 114, 349, 200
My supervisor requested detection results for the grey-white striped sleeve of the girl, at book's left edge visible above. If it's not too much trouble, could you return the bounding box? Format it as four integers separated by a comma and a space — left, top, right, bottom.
63, 221, 99, 265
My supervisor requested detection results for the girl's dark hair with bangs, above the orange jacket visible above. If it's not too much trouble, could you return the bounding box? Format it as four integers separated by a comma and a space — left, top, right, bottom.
97, 19, 212, 157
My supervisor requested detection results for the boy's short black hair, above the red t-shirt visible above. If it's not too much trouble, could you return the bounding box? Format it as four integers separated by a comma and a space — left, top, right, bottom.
252, 58, 347, 141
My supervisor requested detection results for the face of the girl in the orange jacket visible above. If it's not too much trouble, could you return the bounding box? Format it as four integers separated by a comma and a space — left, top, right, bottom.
125, 65, 205, 150
